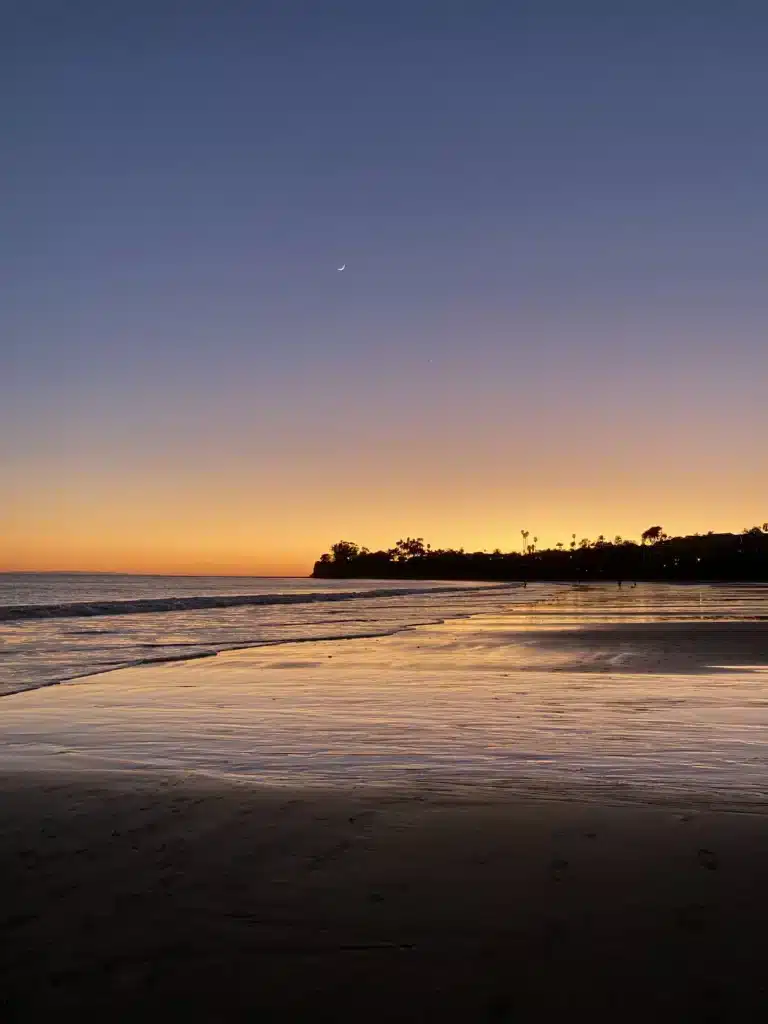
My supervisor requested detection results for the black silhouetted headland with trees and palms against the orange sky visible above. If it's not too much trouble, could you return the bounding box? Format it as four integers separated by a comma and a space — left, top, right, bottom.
312, 522, 768, 582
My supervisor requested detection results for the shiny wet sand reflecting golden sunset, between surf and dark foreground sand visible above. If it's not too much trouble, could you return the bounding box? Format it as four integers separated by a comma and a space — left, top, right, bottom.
0, 588, 768, 808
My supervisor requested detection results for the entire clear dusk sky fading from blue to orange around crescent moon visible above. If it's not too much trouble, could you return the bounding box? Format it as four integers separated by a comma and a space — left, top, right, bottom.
0, 0, 768, 574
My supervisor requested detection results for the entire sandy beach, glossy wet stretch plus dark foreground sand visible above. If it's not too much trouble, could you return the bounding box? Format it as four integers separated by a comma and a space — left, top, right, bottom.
0, 587, 768, 1021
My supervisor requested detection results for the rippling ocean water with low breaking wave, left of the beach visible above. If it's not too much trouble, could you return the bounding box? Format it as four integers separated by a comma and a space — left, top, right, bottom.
0, 572, 540, 695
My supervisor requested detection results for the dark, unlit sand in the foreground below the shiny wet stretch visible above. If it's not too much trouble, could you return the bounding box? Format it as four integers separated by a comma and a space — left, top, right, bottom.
0, 773, 768, 1022
